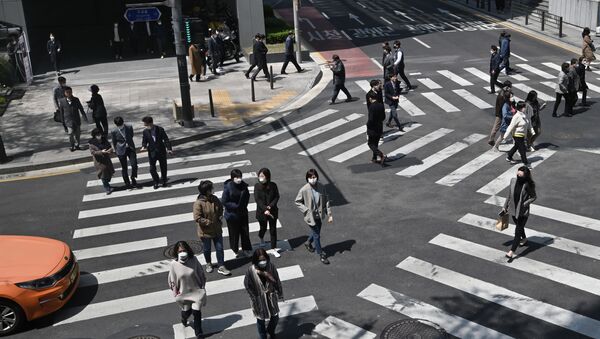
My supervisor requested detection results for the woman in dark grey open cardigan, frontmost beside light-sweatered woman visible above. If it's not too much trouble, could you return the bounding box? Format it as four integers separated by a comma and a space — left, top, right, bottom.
244, 248, 283, 339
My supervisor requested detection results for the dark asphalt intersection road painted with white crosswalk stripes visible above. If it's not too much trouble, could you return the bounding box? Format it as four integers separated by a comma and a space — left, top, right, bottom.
0, 0, 600, 338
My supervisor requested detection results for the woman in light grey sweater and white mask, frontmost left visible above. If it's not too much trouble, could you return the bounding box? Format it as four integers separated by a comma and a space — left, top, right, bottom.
168, 241, 206, 338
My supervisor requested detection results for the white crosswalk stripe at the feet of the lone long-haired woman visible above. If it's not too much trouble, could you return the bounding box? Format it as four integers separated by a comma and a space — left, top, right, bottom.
429, 233, 600, 296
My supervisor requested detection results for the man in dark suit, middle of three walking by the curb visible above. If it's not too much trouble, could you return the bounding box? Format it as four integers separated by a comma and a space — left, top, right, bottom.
111, 117, 138, 188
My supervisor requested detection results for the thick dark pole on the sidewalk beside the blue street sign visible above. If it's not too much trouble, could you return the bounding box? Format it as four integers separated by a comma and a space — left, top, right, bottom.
171, 0, 194, 127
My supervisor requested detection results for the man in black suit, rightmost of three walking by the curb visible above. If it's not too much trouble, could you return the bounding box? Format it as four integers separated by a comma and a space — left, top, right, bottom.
142, 116, 173, 189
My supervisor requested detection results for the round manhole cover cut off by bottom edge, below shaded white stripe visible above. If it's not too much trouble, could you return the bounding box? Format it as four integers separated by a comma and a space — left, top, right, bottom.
380, 319, 448, 339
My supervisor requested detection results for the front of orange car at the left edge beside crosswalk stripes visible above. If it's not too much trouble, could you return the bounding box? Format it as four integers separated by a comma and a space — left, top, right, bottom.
0, 235, 79, 336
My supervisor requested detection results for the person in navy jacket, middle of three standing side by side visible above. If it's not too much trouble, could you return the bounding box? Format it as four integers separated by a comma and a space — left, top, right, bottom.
221, 168, 252, 258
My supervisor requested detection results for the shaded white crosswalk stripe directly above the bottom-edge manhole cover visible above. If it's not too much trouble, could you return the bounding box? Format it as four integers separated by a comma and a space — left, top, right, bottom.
358, 284, 512, 339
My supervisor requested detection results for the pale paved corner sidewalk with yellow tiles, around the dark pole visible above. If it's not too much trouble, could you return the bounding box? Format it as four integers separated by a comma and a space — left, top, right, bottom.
0, 58, 321, 174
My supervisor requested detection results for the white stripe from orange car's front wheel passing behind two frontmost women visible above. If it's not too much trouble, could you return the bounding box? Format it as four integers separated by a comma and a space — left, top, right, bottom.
53, 266, 304, 326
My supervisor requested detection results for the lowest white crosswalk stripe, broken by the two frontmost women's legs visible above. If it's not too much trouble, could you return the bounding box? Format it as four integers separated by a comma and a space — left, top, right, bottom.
173, 295, 318, 339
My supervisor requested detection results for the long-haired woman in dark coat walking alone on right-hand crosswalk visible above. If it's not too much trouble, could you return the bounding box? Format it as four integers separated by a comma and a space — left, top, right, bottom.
501, 166, 537, 262
